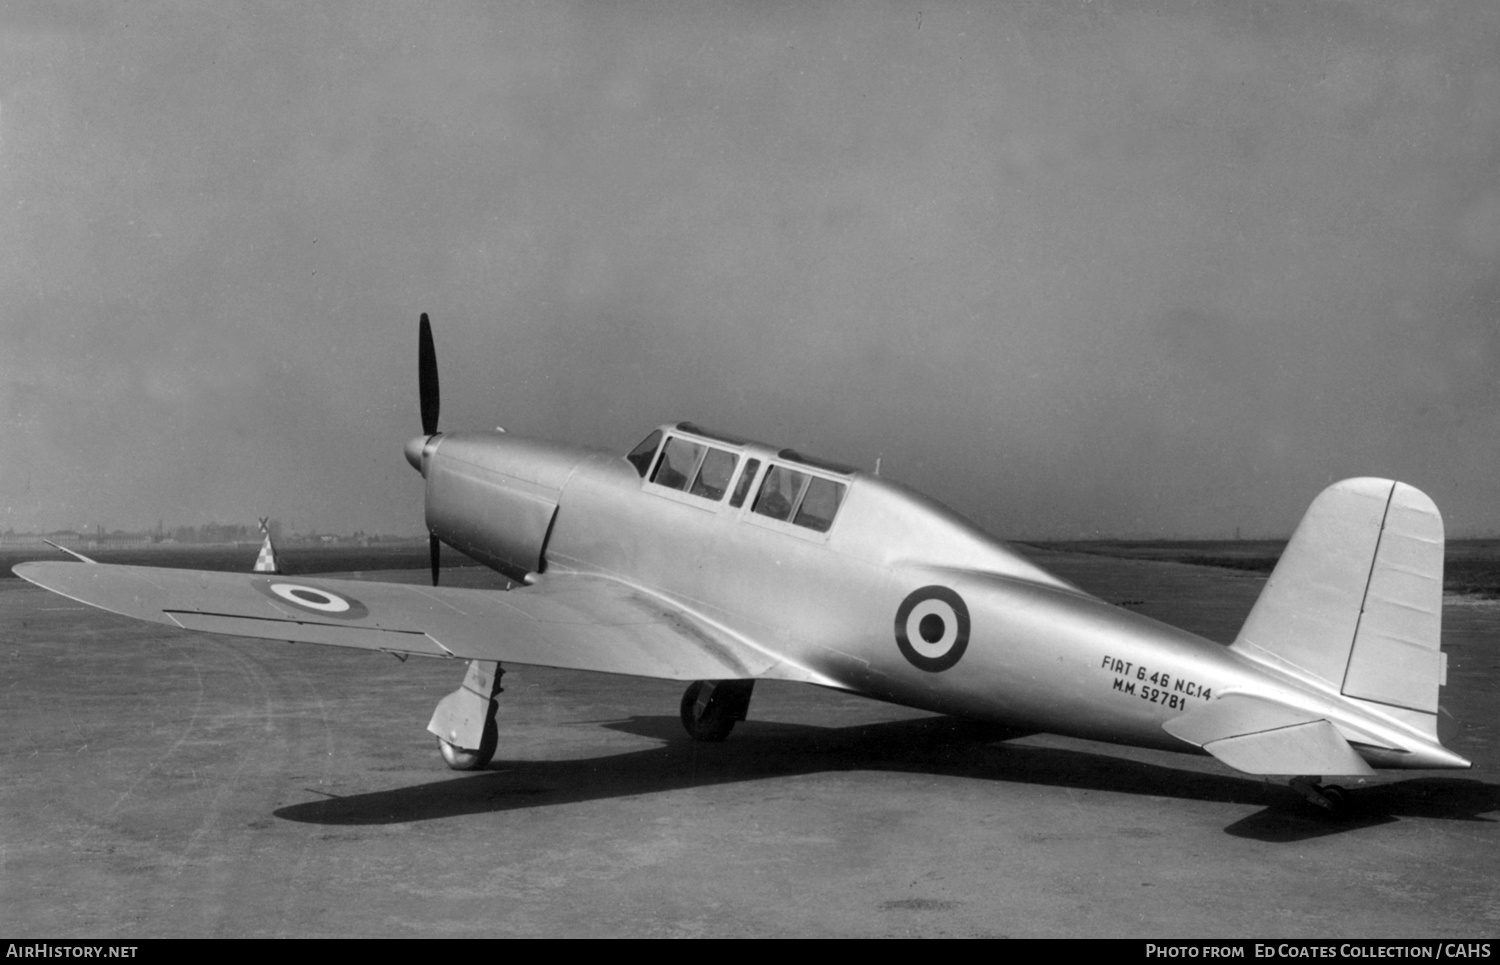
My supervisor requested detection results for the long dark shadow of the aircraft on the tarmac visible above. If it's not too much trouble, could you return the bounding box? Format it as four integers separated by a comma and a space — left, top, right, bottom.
275, 716, 1500, 842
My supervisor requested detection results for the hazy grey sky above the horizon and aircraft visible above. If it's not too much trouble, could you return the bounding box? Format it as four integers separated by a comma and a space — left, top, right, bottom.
0, 0, 1500, 539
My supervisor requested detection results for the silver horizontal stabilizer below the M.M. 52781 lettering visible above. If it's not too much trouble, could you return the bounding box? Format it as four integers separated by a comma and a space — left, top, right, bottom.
1163, 693, 1374, 776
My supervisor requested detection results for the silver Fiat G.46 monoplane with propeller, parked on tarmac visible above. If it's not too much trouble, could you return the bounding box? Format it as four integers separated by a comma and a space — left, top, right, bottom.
15, 315, 1469, 812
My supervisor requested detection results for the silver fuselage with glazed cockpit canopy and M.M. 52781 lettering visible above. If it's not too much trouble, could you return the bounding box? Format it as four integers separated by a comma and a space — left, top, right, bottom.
408, 423, 1461, 767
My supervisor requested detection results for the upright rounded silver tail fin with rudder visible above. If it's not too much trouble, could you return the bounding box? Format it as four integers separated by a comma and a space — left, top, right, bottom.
1233, 479, 1448, 738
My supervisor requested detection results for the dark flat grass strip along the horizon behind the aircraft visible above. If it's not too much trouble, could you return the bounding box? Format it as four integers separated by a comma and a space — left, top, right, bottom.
11, 539, 1500, 599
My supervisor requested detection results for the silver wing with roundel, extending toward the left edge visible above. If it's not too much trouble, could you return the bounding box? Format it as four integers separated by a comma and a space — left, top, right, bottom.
15, 563, 827, 683
